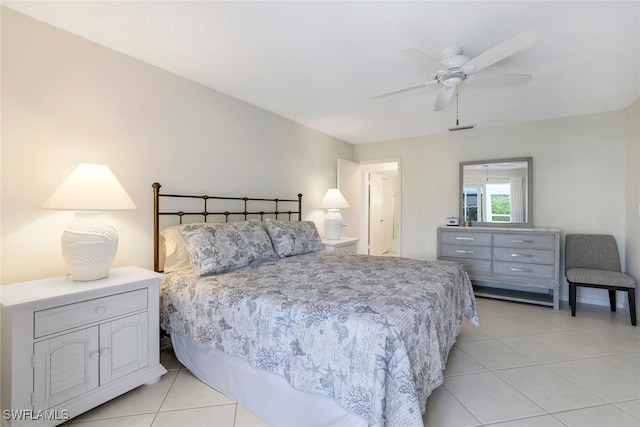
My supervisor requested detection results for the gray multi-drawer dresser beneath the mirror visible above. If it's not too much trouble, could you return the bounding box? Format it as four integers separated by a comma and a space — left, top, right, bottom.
438, 226, 560, 309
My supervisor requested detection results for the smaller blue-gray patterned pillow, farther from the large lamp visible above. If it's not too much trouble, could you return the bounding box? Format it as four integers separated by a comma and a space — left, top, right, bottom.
264, 218, 323, 258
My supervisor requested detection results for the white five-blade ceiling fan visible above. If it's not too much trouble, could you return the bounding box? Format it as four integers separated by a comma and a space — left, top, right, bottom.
372, 28, 544, 111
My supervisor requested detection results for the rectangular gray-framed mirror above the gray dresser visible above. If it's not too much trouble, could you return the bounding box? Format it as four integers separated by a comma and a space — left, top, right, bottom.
460, 157, 533, 228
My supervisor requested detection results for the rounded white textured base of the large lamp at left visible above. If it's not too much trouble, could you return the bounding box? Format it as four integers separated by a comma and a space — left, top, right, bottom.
62, 219, 118, 282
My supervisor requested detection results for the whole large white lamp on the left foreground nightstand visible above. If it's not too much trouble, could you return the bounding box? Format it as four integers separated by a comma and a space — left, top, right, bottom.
42, 163, 137, 282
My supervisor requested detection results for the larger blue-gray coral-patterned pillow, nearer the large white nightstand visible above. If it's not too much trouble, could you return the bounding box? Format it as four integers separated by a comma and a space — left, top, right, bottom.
180, 220, 276, 277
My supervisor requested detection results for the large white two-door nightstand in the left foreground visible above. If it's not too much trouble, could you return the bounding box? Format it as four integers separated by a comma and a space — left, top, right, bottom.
0, 267, 167, 427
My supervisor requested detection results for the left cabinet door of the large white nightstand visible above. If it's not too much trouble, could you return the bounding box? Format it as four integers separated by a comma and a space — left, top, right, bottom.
33, 326, 99, 410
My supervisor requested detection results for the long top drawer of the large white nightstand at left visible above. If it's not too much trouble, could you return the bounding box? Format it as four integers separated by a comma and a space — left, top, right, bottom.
34, 288, 147, 338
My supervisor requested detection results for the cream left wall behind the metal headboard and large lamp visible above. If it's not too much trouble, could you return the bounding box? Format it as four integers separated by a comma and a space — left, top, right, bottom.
0, 8, 353, 284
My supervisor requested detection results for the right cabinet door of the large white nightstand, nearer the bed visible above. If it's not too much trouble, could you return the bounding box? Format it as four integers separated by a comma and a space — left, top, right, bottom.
100, 313, 149, 385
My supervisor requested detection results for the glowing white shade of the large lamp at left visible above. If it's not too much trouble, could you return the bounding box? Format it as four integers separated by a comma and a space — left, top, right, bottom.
42, 163, 137, 211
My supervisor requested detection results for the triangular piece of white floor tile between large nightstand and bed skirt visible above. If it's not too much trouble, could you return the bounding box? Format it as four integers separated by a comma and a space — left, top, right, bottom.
160, 370, 234, 411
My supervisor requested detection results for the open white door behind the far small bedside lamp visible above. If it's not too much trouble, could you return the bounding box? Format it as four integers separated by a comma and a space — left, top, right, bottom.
337, 159, 362, 244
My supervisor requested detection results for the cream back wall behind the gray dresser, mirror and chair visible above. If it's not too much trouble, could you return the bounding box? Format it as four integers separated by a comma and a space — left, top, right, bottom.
354, 111, 640, 304
